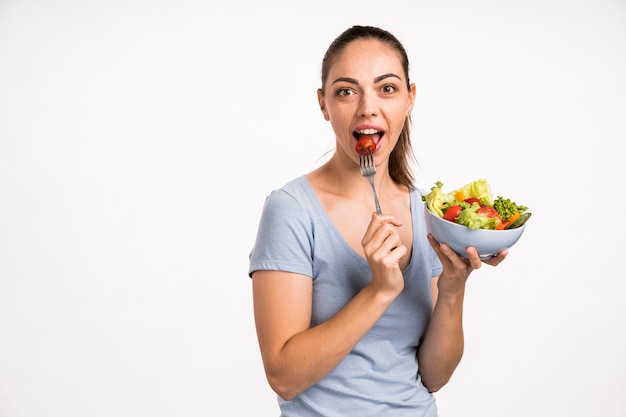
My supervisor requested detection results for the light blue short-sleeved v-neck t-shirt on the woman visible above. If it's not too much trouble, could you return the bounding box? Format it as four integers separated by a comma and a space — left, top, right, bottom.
249, 176, 441, 417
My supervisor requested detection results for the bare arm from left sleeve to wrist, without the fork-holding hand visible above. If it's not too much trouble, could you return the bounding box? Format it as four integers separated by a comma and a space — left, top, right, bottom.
252, 271, 395, 400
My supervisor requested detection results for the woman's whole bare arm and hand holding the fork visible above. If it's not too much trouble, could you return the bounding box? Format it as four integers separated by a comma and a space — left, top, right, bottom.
252, 215, 407, 400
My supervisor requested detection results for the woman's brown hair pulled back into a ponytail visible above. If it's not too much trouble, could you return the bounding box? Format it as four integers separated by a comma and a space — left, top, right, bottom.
320, 26, 415, 188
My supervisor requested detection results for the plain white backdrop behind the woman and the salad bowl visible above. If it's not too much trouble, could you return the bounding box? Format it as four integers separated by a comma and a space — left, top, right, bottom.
0, 0, 626, 417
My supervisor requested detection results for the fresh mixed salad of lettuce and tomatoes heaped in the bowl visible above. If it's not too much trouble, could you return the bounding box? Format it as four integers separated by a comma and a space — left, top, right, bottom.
422, 179, 531, 230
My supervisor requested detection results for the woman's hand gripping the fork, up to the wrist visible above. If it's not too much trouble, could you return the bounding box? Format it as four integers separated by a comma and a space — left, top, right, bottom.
361, 213, 408, 297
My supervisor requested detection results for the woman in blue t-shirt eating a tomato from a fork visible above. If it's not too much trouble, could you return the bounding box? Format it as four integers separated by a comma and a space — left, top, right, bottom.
250, 26, 507, 417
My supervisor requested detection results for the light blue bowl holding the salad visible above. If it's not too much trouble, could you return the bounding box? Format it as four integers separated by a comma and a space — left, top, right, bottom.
424, 205, 526, 259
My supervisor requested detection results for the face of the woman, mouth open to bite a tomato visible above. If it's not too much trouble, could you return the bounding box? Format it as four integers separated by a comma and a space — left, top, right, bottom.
318, 39, 415, 164
